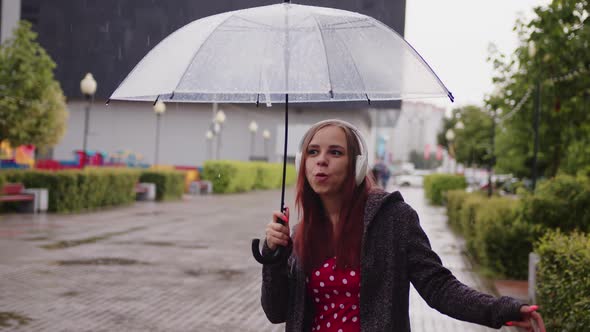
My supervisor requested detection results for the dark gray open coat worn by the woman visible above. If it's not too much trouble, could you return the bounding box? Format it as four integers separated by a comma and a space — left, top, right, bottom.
262, 191, 521, 332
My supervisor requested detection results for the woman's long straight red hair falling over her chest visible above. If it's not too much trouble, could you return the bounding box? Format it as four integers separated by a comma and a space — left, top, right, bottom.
293, 121, 375, 273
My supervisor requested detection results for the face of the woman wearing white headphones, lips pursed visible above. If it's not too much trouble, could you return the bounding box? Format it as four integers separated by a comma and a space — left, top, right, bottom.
305, 126, 348, 196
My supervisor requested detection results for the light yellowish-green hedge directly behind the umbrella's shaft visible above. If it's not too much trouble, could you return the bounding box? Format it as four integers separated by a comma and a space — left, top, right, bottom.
201, 160, 295, 193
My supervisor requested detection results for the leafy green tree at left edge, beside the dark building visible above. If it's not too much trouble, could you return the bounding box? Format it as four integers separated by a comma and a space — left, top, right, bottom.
0, 21, 67, 149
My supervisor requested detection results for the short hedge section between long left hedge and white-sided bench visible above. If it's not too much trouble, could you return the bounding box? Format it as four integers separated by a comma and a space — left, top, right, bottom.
139, 170, 185, 201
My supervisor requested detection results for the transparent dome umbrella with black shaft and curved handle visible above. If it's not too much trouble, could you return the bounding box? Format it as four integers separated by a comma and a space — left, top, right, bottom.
107, 2, 453, 263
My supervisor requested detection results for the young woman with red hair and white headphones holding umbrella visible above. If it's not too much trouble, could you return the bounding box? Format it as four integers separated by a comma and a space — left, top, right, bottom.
262, 120, 545, 332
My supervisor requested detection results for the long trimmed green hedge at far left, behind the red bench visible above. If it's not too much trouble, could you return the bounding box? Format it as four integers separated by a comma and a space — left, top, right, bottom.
3, 168, 140, 213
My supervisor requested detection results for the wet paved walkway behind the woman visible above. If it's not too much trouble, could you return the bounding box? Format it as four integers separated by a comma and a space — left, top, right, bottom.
0, 188, 509, 332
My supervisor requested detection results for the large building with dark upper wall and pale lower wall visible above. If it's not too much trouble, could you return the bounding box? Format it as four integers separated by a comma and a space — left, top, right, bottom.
0, 0, 448, 165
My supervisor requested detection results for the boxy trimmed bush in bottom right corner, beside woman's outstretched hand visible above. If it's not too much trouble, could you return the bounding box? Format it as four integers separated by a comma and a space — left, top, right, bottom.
535, 231, 590, 332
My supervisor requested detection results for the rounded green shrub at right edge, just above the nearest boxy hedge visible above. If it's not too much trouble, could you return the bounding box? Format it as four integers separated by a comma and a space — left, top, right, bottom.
520, 175, 590, 232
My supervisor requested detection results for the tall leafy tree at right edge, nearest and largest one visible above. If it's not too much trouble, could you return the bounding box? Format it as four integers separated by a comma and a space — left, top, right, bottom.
486, 0, 590, 177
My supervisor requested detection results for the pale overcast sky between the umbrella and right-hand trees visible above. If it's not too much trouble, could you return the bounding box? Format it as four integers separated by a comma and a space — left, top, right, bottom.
405, 0, 551, 109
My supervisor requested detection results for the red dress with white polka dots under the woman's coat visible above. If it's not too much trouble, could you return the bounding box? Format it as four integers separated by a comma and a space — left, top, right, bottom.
306, 257, 361, 332
